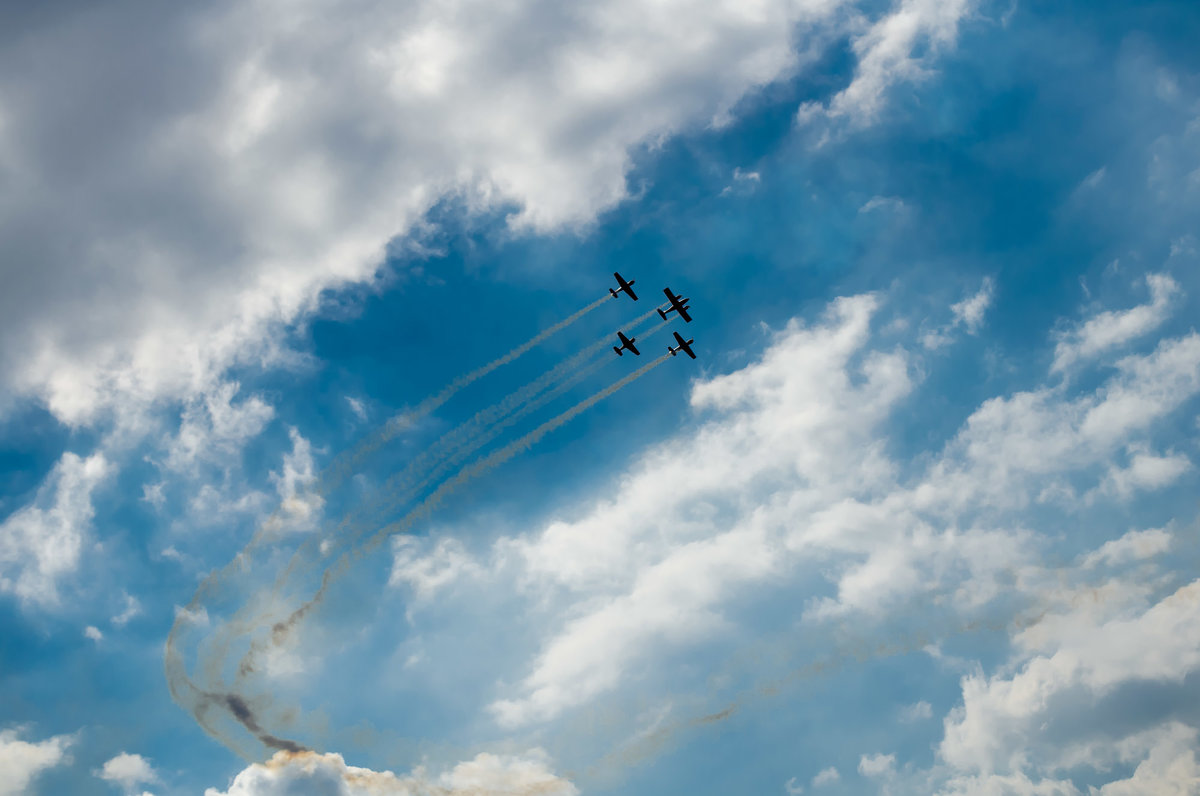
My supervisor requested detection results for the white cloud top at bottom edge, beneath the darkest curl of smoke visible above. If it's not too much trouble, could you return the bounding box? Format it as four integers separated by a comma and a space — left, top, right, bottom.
204, 749, 578, 796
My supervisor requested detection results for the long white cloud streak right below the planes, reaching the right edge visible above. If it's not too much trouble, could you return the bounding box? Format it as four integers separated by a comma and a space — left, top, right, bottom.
475, 278, 1200, 726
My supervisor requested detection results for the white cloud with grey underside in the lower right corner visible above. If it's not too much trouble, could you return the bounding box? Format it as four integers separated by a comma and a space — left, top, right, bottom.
940, 579, 1200, 774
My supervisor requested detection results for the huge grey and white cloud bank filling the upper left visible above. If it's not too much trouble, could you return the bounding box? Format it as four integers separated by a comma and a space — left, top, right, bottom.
0, 0, 892, 429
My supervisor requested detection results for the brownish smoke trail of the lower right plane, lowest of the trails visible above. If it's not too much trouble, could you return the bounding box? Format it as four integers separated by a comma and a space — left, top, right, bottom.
238, 354, 670, 678
